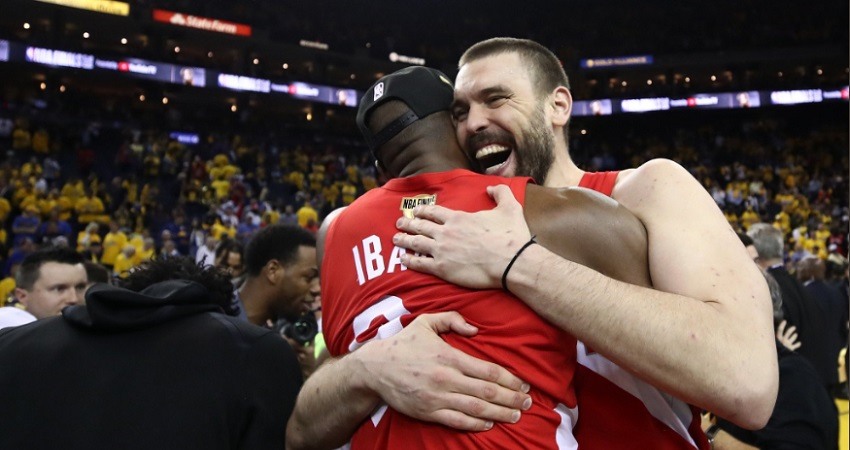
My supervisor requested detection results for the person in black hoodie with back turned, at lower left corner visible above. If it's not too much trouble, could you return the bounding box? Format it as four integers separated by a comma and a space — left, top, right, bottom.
0, 258, 302, 450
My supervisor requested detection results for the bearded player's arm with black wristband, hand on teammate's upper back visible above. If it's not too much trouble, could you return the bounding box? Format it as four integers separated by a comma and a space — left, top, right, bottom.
394, 161, 778, 428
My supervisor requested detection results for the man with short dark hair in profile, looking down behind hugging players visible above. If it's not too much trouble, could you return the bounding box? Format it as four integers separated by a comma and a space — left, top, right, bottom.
234, 225, 318, 378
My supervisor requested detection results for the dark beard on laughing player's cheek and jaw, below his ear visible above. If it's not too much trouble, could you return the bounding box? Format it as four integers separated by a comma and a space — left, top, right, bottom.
514, 107, 555, 185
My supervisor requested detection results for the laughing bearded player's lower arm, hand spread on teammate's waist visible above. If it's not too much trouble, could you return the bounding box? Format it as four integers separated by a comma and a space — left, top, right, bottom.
286, 209, 531, 449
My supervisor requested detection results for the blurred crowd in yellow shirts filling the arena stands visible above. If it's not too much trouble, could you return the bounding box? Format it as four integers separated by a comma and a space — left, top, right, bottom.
0, 95, 850, 310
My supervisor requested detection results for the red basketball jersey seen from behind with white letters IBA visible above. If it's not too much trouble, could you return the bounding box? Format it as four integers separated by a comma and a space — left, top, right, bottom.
322, 170, 576, 449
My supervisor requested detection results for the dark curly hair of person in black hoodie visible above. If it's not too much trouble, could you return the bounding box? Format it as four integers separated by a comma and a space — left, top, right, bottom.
117, 256, 237, 315
